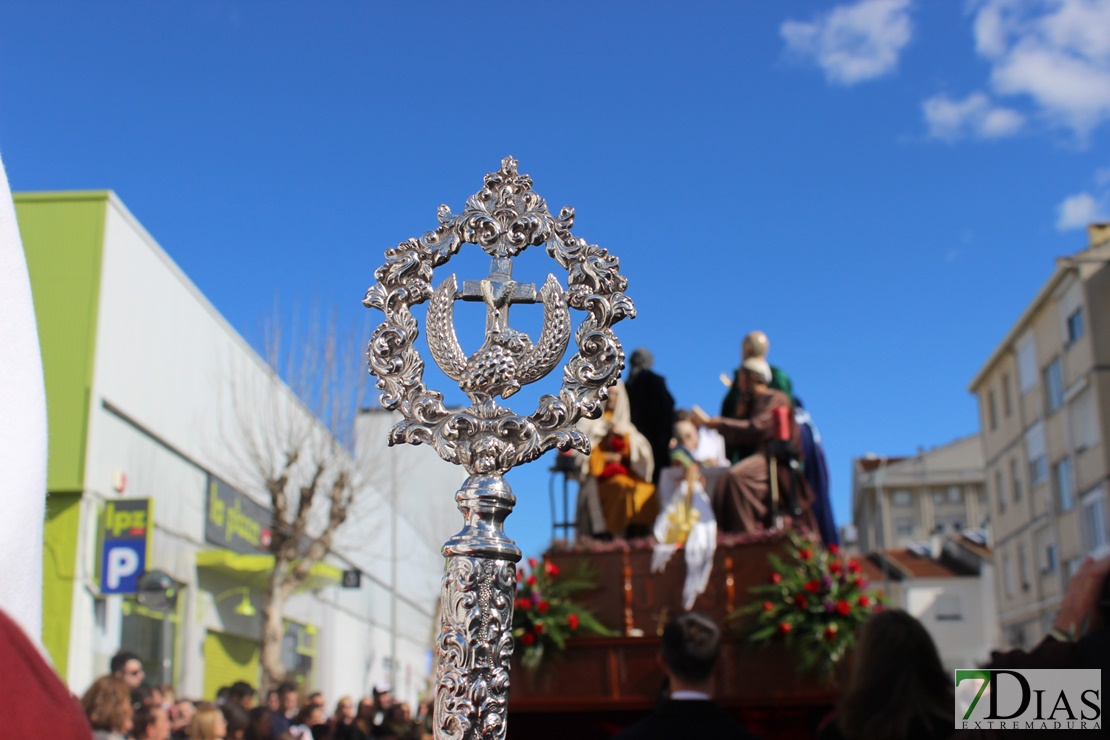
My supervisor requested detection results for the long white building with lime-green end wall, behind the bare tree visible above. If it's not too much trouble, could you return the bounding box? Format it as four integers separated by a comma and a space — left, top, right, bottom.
21, 192, 465, 702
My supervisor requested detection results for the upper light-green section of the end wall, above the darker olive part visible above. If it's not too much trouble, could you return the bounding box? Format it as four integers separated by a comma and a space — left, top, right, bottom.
13, 191, 108, 492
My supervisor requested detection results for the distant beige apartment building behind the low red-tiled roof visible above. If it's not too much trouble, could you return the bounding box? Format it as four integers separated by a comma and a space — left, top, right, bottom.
851, 435, 990, 553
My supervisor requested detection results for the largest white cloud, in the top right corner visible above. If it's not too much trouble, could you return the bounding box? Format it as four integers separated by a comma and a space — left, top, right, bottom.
973, 0, 1110, 139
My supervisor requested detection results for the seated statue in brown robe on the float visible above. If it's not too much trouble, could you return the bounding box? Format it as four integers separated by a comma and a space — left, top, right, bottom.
707, 358, 816, 533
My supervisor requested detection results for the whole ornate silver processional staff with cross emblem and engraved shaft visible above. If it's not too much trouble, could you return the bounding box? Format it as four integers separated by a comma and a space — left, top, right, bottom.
363, 158, 636, 740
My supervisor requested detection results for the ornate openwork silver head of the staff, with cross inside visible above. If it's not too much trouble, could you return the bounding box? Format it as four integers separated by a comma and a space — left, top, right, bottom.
363, 158, 636, 475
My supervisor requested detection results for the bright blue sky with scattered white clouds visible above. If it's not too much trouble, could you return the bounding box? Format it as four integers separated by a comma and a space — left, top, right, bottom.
0, 0, 1110, 561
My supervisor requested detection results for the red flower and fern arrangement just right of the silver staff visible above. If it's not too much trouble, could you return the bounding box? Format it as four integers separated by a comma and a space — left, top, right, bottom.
513, 558, 614, 671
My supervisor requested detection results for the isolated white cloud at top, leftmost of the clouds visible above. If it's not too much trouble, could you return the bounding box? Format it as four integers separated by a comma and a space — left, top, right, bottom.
780, 0, 912, 85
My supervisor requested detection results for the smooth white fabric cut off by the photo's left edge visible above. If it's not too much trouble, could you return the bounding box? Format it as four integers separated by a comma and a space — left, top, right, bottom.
0, 151, 47, 643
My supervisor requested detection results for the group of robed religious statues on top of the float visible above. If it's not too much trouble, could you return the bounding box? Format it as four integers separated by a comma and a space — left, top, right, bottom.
577, 332, 838, 545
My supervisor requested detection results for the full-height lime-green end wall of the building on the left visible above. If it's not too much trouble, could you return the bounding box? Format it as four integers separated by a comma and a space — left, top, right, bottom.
13, 192, 109, 678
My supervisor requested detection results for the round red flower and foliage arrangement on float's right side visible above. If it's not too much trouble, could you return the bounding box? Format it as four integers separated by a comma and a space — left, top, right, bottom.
730, 534, 886, 676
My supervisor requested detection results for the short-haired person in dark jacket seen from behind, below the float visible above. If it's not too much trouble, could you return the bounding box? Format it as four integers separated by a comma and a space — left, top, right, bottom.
615, 611, 758, 740
